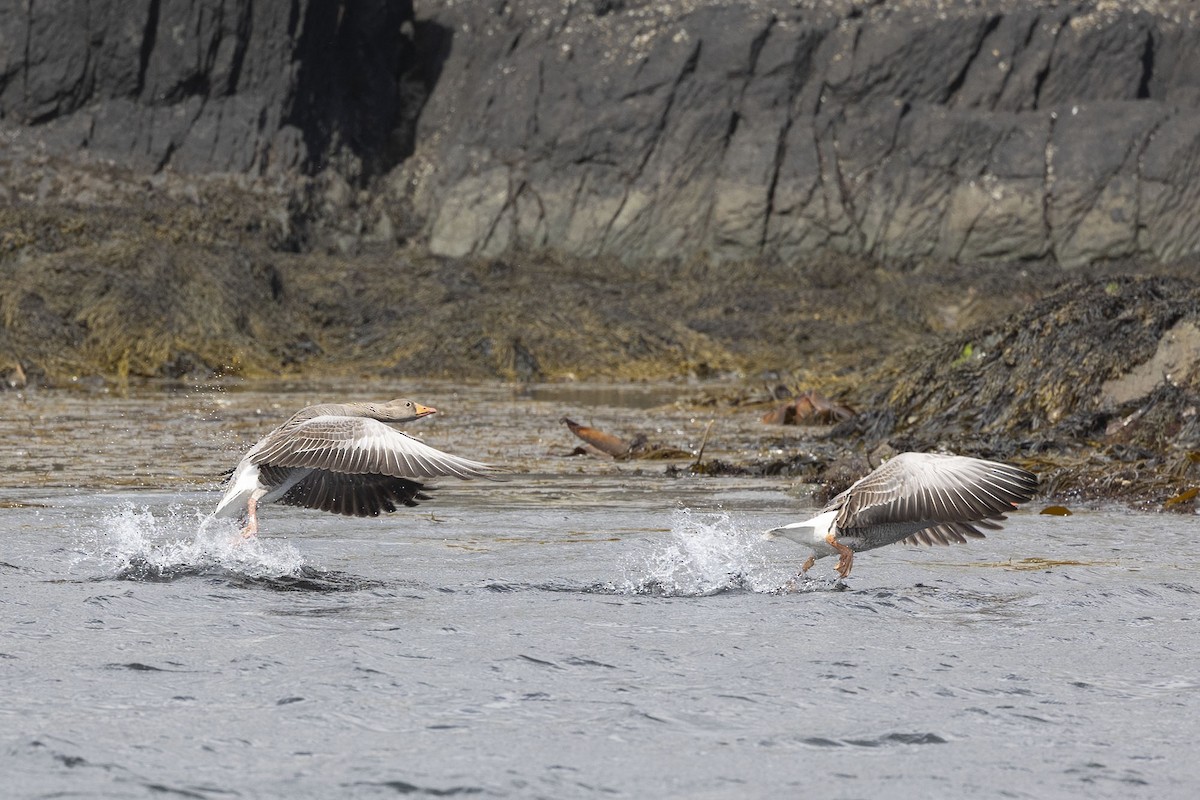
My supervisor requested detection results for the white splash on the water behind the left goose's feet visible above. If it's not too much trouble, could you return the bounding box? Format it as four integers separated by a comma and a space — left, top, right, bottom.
78, 503, 305, 581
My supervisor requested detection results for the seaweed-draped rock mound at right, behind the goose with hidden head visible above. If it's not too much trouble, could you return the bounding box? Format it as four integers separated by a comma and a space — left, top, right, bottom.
830, 276, 1200, 511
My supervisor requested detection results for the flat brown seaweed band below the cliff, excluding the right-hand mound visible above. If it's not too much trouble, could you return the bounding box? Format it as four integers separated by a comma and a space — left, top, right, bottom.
0, 165, 1070, 390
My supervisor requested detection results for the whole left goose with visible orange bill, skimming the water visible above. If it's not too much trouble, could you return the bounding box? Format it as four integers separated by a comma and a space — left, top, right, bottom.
214, 399, 496, 537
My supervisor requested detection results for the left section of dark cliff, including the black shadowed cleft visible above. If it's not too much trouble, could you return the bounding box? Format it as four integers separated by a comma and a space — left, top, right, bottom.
0, 0, 415, 178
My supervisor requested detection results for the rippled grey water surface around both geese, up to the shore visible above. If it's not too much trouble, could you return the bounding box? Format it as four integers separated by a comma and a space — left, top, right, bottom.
0, 384, 1200, 798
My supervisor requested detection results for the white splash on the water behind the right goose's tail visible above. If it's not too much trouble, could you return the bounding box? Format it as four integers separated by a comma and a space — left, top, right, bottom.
611, 509, 794, 597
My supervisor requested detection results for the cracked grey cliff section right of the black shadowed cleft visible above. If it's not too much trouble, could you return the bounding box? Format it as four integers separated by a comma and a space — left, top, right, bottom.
413, 0, 1200, 265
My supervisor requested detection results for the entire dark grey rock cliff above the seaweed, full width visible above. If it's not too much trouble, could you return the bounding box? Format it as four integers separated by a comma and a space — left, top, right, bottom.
0, 0, 1200, 265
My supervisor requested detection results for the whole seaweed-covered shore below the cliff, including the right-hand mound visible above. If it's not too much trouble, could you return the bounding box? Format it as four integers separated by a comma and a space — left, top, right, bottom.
0, 169, 1200, 511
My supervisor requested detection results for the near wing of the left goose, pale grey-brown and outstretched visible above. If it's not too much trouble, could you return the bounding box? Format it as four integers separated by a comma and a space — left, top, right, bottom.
247, 415, 494, 480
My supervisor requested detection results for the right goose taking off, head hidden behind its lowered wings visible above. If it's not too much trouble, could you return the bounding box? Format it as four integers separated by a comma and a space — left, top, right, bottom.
764, 452, 1038, 578
